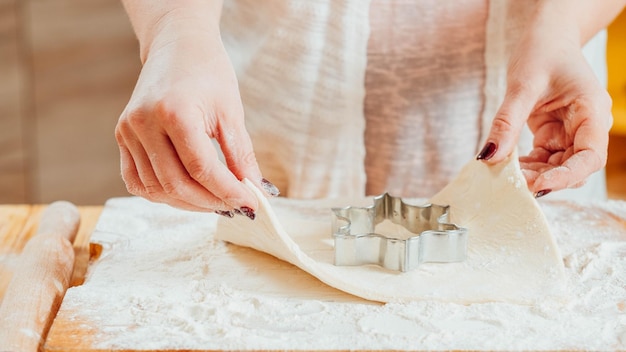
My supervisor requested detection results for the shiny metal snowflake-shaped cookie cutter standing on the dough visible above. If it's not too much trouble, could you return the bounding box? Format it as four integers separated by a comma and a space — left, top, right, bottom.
332, 193, 467, 272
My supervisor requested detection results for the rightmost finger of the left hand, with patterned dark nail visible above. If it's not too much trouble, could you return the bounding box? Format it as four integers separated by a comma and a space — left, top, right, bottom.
217, 105, 280, 197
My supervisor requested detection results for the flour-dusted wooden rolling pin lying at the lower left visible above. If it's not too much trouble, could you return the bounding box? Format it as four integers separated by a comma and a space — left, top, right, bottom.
0, 201, 80, 352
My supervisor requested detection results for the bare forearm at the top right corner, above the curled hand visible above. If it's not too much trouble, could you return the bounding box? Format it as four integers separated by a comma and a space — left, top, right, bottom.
533, 0, 626, 46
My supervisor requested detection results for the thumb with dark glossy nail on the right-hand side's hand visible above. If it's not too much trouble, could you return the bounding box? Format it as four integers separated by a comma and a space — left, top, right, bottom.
476, 85, 538, 164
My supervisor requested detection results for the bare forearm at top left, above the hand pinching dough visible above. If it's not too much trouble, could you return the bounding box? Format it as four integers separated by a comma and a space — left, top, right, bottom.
122, 0, 222, 63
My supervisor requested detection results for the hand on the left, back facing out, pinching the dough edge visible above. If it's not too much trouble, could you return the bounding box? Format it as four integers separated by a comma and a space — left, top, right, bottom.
115, 1, 277, 218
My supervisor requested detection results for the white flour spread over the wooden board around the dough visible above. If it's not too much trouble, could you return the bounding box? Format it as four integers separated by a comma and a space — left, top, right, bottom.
59, 198, 626, 350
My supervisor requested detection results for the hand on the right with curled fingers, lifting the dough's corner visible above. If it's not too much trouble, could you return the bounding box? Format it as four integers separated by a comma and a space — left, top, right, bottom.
478, 0, 623, 196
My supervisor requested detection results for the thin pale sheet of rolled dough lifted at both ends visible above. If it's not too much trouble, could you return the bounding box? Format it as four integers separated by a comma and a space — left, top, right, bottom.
216, 155, 565, 304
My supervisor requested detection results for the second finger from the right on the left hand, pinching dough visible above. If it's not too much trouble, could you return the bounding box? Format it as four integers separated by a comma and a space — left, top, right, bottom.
165, 104, 258, 212
